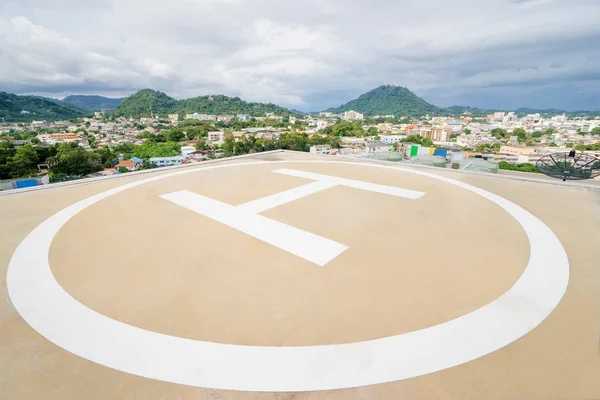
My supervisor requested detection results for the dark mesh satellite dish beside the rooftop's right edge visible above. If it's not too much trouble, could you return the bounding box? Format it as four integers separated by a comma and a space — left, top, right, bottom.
535, 150, 600, 182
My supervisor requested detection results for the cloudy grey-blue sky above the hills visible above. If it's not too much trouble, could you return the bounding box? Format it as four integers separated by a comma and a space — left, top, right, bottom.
0, 0, 600, 111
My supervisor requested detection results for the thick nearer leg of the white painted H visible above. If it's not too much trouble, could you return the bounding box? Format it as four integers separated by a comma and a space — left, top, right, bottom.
160, 190, 348, 267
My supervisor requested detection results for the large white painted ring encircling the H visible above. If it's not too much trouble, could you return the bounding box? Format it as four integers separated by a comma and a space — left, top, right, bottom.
7, 161, 569, 392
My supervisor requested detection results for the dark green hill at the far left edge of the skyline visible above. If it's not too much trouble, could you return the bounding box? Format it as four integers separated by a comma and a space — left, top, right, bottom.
0, 92, 88, 122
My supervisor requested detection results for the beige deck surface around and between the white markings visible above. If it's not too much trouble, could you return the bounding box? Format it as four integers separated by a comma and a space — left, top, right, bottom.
0, 153, 600, 399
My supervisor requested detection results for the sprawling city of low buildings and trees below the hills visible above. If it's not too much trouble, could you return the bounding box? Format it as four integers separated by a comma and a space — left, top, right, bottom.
0, 86, 600, 190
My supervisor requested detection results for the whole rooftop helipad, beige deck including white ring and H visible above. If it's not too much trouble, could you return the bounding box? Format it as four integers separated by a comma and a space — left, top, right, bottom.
0, 153, 600, 399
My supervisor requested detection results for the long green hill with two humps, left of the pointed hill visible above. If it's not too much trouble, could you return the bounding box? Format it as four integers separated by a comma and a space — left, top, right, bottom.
115, 89, 293, 117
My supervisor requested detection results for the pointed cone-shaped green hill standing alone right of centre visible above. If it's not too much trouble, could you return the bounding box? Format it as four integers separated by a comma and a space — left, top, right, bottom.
326, 85, 443, 117
